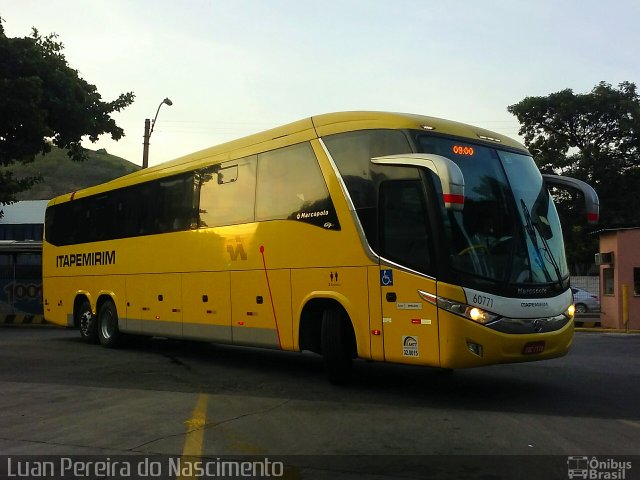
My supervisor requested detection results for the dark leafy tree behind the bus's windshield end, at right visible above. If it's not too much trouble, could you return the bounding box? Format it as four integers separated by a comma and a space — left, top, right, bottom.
507, 82, 640, 270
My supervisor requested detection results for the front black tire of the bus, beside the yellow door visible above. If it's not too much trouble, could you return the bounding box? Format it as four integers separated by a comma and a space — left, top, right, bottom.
322, 308, 352, 385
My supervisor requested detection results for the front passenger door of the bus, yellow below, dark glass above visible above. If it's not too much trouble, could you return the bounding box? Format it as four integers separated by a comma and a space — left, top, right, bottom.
378, 179, 439, 365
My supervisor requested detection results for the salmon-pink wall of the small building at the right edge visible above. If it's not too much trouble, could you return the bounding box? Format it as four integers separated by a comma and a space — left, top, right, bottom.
600, 228, 640, 329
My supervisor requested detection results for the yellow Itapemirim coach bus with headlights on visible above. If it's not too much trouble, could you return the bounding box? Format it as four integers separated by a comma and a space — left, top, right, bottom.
43, 112, 598, 382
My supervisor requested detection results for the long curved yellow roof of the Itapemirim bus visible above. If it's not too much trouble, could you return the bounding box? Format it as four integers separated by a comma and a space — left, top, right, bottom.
49, 112, 526, 205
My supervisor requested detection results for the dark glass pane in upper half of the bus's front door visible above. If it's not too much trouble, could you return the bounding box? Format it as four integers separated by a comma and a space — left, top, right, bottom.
380, 180, 432, 273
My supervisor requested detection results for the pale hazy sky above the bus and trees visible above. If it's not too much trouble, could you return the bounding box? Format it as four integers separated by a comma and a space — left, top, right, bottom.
0, 0, 640, 165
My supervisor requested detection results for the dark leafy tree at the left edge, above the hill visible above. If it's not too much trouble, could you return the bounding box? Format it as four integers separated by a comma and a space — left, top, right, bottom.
0, 18, 134, 205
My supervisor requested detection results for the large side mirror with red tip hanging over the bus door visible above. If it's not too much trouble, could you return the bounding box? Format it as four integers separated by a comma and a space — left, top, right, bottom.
371, 153, 464, 210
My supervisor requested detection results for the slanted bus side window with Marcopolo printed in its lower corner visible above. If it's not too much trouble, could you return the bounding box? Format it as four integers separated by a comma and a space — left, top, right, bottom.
256, 143, 339, 229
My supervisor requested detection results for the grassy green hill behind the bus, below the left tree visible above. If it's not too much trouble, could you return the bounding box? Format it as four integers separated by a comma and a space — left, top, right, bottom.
5, 147, 140, 200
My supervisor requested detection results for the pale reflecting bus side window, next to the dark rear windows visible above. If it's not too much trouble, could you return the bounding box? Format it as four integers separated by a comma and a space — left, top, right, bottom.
197, 155, 256, 227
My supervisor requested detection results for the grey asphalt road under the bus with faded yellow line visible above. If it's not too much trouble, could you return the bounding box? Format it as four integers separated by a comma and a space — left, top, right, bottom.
0, 327, 640, 479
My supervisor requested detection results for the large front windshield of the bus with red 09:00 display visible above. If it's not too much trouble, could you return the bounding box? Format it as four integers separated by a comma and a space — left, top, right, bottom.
420, 136, 568, 285
